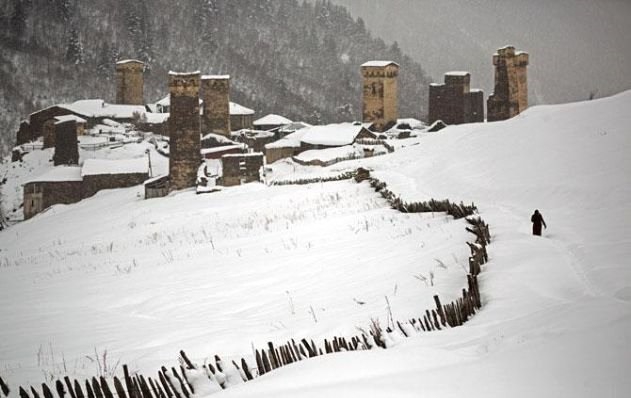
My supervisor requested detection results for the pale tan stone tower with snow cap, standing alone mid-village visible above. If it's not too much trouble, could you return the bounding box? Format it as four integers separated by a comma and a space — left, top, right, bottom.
361, 61, 399, 131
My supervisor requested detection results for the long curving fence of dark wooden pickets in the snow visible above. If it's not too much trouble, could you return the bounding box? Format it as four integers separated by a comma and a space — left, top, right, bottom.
0, 173, 491, 398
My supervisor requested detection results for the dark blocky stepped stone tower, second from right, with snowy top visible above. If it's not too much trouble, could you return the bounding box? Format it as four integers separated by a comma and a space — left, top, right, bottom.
429, 72, 484, 124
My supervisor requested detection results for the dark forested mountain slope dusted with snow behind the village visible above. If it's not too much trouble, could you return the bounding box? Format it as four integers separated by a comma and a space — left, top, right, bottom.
0, 0, 429, 151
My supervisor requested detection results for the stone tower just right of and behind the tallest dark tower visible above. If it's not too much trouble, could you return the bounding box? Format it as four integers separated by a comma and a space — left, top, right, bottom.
201, 75, 230, 137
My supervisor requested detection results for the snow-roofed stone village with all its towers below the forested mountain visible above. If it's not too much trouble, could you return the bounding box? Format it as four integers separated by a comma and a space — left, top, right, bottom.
13, 46, 528, 218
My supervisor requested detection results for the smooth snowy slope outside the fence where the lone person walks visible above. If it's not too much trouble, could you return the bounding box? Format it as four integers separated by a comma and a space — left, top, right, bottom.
218, 92, 631, 397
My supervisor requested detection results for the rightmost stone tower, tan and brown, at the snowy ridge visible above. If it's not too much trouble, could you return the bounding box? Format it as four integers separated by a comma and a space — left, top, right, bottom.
487, 46, 528, 122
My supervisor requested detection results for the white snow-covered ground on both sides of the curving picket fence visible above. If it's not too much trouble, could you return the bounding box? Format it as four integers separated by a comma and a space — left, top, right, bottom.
0, 92, 631, 397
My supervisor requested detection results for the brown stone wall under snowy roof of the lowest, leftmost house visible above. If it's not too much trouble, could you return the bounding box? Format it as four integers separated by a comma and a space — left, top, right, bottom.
24, 181, 81, 220
